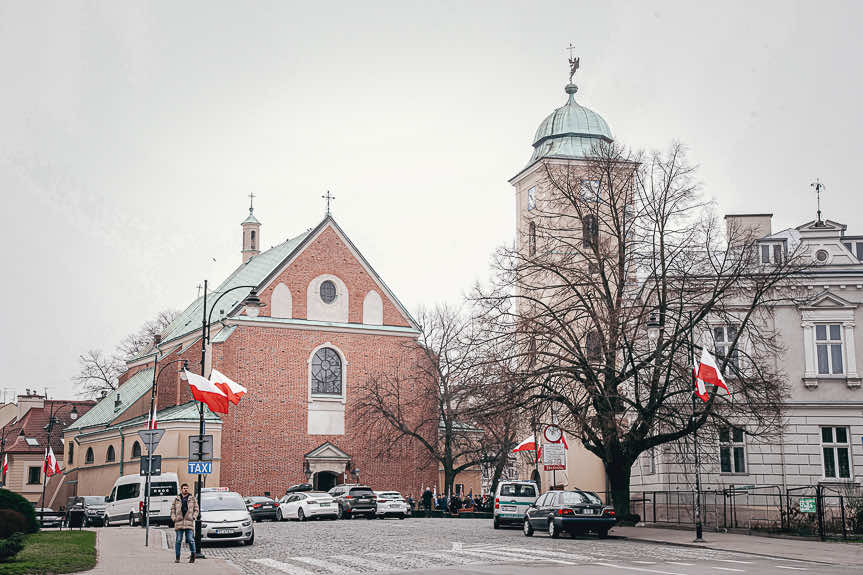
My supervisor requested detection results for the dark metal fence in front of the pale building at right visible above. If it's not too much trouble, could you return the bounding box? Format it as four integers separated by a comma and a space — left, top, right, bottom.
601, 485, 863, 539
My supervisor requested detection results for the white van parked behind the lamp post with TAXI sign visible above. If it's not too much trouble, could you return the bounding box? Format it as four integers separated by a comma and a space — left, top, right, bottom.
104, 473, 180, 526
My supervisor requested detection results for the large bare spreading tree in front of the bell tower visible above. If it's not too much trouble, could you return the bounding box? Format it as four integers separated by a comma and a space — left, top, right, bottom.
476, 144, 799, 516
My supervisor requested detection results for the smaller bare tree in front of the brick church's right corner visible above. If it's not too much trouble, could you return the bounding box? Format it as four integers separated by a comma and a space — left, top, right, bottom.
357, 306, 511, 493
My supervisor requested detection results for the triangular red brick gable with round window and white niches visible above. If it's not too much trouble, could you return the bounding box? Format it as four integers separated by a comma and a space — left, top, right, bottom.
259, 217, 416, 328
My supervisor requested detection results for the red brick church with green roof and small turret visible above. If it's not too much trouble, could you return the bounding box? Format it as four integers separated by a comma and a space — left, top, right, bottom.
66, 208, 438, 497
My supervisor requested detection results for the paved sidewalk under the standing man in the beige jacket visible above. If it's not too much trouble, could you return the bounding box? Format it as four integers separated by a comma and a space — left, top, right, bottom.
85, 527, 240, 575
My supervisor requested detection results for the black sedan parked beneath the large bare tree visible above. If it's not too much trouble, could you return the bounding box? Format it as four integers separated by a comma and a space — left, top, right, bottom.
523, 490, 617, 539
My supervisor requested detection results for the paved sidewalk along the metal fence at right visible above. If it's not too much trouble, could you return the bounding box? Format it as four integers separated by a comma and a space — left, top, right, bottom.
611, 526, 863, 567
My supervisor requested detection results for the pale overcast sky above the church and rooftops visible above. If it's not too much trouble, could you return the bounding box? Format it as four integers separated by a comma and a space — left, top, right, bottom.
0, 0, 863, 398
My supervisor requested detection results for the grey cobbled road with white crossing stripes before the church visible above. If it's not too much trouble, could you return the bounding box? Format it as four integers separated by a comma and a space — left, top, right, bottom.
186, 519, 860, 575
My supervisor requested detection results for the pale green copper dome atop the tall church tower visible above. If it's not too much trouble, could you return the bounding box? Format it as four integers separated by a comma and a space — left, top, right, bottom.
530, 84, 614, 162
